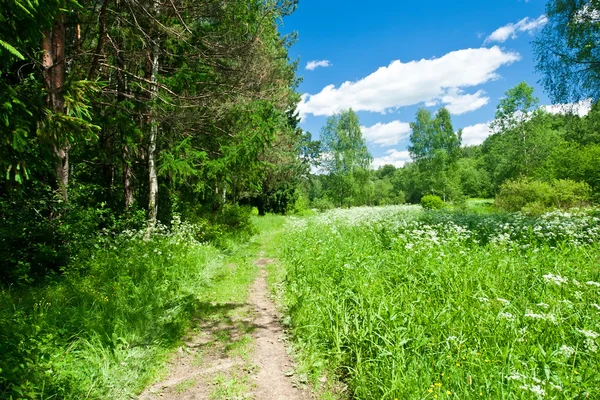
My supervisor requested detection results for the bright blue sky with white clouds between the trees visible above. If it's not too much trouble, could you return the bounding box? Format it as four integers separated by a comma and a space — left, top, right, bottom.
283, 0, 576, 167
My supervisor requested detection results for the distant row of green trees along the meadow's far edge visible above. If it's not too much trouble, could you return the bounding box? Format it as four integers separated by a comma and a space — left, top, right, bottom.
301, 82, 600, 209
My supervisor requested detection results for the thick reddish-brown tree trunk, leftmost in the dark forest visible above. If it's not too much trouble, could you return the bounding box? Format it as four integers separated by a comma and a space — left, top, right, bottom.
42, 14, 70, 202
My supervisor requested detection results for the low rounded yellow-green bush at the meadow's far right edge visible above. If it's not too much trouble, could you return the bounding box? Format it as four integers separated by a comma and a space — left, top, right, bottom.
496, 179, 591, 215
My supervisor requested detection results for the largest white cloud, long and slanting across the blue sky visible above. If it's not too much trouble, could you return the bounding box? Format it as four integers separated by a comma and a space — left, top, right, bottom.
298, 46, 521, 118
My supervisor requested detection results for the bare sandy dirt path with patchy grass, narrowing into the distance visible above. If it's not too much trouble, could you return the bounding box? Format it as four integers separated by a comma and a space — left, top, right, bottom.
139, 253, 313, 400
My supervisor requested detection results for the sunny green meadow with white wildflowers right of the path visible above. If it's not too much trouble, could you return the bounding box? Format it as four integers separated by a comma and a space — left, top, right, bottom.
283, 207, 600, 400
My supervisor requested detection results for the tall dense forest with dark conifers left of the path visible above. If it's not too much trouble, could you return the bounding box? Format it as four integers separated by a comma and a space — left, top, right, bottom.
0, 0, 305, 279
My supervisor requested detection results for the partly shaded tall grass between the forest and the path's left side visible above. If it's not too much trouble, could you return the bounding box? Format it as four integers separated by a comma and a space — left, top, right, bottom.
0, 223, 221, 399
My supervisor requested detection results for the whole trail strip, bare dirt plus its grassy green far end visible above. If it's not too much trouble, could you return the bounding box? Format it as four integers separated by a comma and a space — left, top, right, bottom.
140, 217, 313, 400
